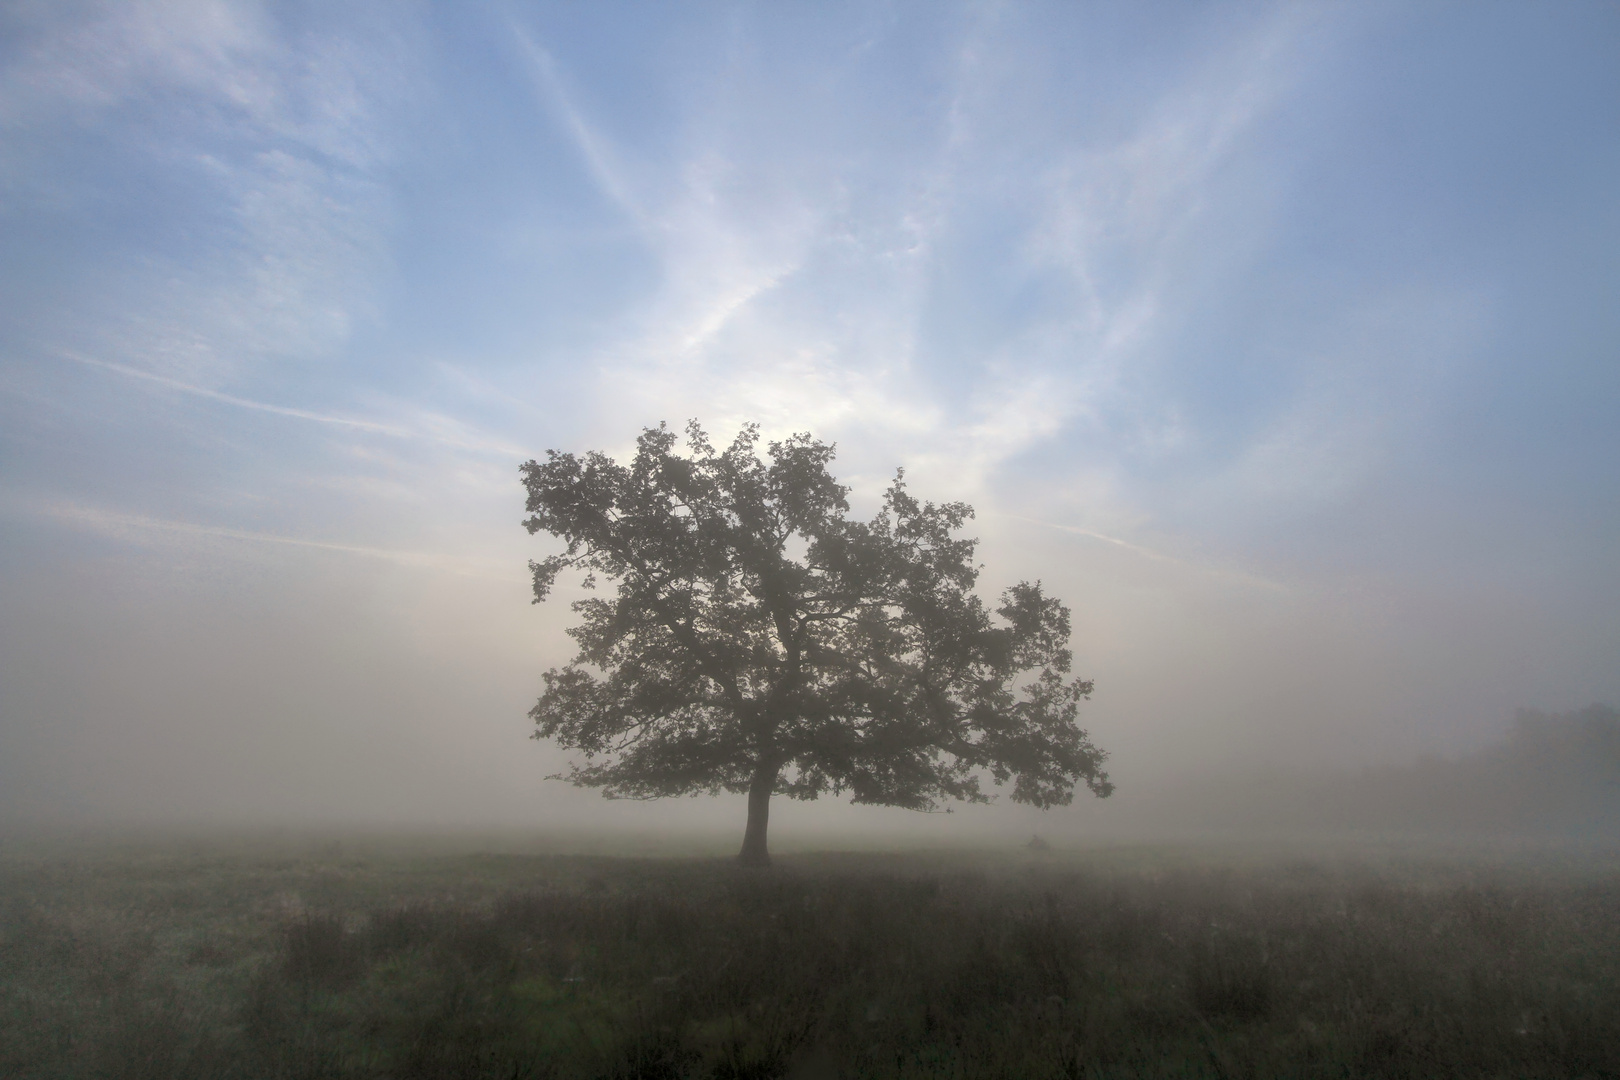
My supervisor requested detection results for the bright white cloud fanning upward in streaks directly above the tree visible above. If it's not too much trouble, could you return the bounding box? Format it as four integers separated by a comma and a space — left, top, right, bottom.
505, 4, 1298, 521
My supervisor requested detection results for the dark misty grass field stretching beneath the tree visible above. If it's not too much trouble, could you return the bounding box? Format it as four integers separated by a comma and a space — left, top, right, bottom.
0, 840, 1620, 1080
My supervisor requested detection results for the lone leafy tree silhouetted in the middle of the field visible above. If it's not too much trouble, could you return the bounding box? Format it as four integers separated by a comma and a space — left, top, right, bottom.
522, 421, 1113, 865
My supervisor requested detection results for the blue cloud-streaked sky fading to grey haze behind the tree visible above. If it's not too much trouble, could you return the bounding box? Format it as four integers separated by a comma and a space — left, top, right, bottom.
0, 0, 1620, 837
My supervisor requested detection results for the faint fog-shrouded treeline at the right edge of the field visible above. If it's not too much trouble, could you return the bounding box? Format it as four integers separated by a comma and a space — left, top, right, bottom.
1152, 704, 1620, 837
